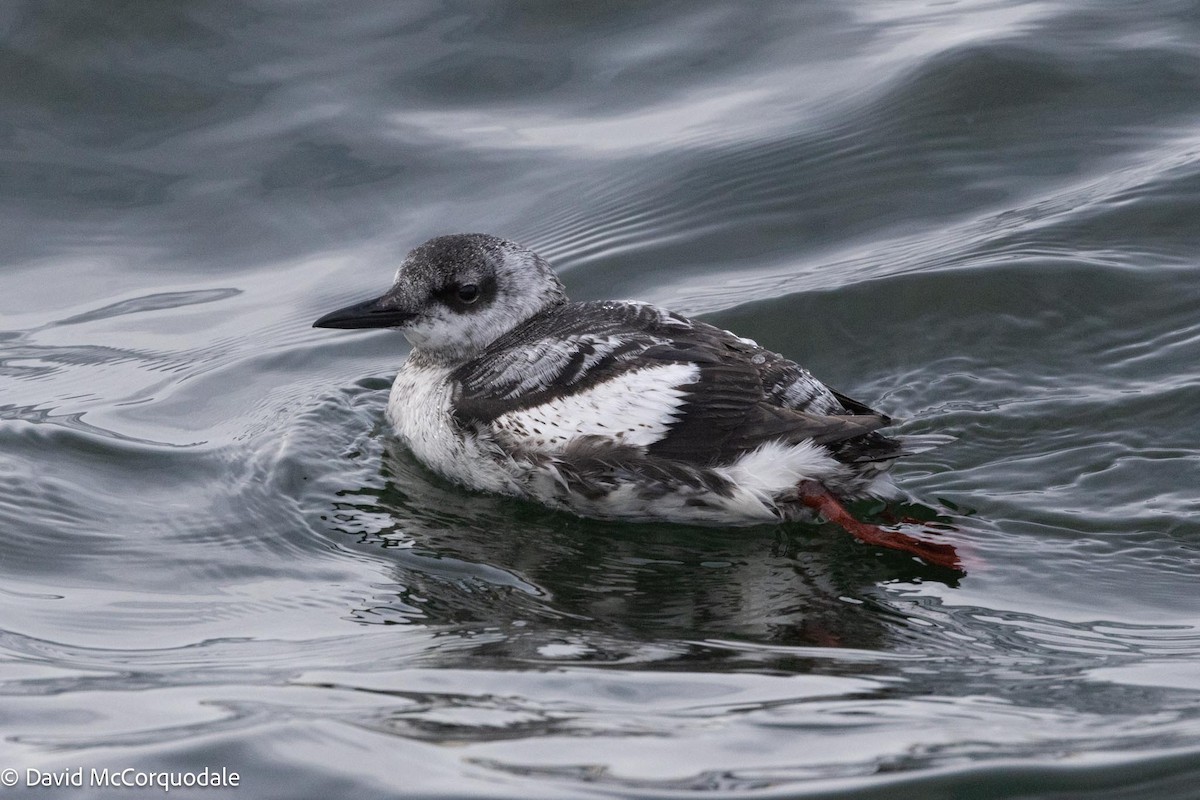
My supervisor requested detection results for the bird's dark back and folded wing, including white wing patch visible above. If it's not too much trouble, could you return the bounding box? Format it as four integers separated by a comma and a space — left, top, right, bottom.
451, 302, 899, 467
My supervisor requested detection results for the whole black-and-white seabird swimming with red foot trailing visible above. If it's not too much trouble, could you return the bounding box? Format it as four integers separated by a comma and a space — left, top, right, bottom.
313, 234, 958, 567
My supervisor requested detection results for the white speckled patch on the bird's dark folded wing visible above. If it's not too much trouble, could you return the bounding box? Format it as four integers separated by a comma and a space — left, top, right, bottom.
492, 363, 700, 452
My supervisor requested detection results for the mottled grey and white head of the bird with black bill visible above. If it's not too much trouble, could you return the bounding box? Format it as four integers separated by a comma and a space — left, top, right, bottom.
313, 234, 566, 362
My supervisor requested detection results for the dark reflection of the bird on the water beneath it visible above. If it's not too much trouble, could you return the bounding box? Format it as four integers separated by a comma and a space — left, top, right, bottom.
335, 443, 956, 663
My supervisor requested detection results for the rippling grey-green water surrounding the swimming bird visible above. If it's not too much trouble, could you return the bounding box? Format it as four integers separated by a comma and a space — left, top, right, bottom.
0, 0, 1200, 800
